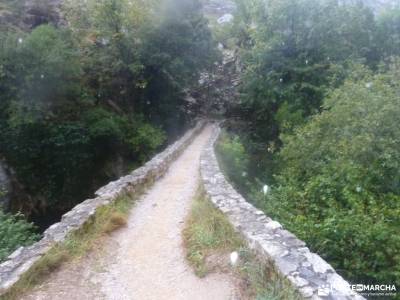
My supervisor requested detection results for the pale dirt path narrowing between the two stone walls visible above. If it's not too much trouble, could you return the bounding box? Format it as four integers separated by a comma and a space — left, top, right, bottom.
23, 126, 235, 300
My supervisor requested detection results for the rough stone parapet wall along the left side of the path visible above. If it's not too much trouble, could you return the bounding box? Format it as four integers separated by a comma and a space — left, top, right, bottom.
0, 121, 205, 296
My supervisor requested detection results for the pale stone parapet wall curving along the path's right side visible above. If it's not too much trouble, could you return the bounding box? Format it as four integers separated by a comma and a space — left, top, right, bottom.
200, 125, 364, 300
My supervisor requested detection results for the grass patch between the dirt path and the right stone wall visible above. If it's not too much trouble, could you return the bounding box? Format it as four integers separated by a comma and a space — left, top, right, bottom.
183, 189, 303, 300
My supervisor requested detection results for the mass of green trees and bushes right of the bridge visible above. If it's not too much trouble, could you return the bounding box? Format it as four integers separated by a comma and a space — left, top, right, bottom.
218, 0, 400, 284
